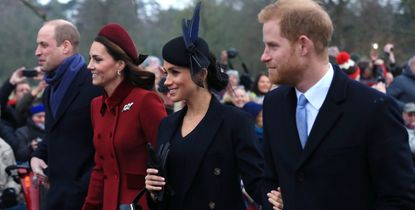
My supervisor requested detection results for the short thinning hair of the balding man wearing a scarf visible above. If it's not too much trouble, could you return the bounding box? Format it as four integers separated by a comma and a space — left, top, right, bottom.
44, 19, 80, 53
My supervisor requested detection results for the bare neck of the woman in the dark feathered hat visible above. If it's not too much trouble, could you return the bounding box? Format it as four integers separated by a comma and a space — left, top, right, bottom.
186, 90, 212, 117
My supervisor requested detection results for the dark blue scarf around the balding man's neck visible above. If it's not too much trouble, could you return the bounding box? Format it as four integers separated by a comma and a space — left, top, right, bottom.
45, 54, 85, 117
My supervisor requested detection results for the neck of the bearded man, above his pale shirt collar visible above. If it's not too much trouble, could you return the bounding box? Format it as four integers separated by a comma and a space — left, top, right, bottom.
295, 60, 330, 93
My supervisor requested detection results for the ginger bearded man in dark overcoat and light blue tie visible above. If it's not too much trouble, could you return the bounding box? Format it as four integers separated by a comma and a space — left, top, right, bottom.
258, 0, 415, 210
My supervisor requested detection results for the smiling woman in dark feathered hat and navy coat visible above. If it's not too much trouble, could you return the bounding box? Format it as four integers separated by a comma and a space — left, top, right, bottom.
146, 3, 263, 210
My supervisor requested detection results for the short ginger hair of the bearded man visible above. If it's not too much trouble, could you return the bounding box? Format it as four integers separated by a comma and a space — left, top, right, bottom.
258, 0, 334, 55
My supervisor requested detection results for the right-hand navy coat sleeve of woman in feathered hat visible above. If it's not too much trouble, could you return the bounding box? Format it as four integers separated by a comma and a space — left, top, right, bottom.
232, 112, 264, 204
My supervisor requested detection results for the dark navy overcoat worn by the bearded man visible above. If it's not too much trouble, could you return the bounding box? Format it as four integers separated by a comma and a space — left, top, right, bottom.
263, 66, 415, 210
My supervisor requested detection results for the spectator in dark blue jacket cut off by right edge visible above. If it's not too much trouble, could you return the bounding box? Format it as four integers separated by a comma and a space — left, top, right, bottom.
386, 55, 415, 108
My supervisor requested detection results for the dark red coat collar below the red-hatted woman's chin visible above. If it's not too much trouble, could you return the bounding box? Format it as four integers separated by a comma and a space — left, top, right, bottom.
101, 80, 134, 114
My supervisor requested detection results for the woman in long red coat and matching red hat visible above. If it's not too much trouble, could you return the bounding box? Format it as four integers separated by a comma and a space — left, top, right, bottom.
83, 24, 166, 210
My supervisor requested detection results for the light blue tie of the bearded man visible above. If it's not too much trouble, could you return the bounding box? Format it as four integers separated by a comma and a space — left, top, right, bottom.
295, 94, 308, 148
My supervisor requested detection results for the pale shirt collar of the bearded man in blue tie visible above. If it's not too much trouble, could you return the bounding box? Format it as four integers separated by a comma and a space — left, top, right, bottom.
295, 64, 334, 110
